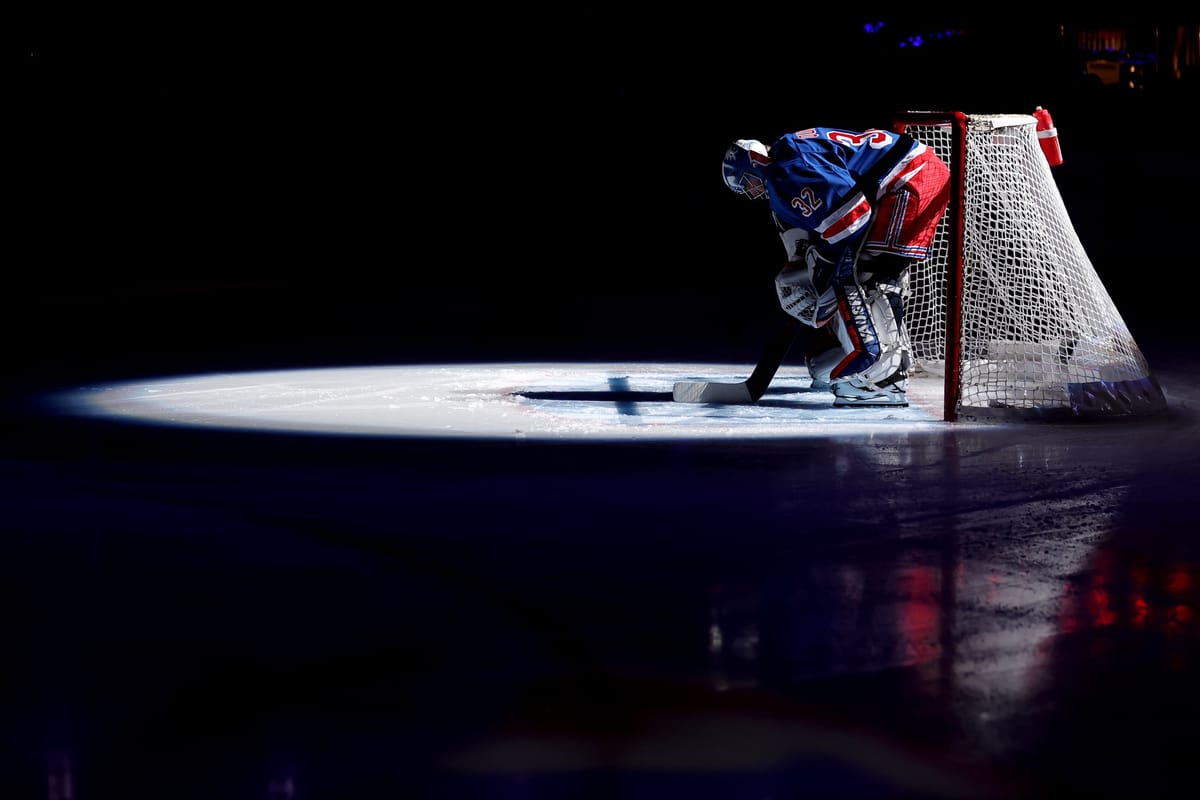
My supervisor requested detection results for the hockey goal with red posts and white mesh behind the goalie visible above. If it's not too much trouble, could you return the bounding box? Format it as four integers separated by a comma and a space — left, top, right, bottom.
895, 112, 1165, 421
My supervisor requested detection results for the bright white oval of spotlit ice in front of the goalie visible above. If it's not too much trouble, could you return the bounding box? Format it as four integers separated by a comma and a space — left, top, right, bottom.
56, 362, 960, 440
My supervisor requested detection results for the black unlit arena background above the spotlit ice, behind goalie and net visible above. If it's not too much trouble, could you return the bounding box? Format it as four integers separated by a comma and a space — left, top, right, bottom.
11, 6, 1195, 383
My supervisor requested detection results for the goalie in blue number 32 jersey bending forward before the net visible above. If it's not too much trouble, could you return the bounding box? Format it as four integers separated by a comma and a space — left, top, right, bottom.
722, 127, 950, 407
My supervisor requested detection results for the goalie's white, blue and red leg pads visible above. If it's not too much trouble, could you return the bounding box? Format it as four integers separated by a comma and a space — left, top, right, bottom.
808, 267, 911, 383
